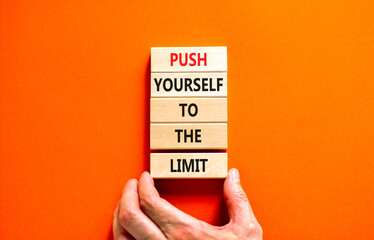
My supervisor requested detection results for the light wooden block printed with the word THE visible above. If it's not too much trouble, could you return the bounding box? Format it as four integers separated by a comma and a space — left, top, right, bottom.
150, 123, 227, 150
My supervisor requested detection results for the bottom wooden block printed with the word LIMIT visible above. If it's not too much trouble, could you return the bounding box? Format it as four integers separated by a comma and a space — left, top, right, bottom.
151, 153, 227, 178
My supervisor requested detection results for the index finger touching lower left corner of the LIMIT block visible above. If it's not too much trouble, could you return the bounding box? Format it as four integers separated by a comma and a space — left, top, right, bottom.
139, 172, 208, 238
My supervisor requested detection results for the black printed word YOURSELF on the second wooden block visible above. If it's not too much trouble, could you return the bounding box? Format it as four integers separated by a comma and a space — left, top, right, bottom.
153, 78, 223, 92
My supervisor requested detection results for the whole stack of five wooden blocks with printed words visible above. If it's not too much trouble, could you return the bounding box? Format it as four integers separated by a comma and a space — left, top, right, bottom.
150, 47, 227, 178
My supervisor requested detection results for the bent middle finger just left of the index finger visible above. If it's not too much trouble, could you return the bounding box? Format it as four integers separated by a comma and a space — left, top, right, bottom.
118, 179, 165, 240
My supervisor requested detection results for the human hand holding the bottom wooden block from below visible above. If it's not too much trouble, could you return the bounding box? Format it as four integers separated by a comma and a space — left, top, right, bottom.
113, 169, 262, 240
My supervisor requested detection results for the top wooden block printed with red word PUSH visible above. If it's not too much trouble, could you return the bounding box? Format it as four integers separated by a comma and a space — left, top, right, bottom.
151, 47, 227, 72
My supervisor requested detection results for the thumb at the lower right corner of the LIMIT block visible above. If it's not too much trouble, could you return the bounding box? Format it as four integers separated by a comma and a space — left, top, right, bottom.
223, 168, 253, 225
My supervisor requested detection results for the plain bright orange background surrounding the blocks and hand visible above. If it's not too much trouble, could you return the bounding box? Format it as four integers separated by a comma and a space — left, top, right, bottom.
0, 0, 374, 240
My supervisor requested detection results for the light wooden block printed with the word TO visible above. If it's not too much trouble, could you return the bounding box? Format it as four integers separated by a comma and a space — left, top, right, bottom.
151, 98, 227, 123
